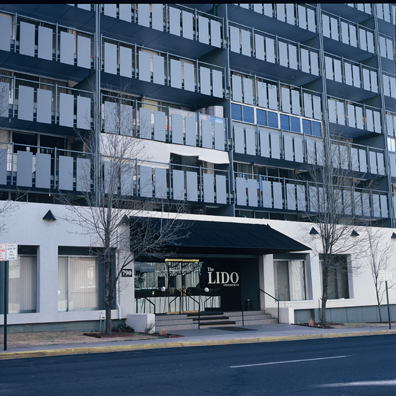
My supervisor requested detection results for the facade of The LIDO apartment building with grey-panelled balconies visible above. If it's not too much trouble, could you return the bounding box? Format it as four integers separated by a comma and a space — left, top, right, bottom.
0, 3, 396, 330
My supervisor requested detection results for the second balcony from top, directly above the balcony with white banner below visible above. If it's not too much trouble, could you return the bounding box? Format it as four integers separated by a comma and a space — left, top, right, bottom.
102, 38, 226, 107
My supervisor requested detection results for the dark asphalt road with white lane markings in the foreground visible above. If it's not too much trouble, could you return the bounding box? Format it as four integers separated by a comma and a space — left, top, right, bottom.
0, 335, 396, 396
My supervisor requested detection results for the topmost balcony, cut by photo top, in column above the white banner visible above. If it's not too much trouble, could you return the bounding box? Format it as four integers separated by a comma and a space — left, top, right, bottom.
101, 4, 224, 59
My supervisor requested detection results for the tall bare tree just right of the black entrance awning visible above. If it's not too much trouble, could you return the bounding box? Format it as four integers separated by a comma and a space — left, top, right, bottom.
303, 140, 370, 325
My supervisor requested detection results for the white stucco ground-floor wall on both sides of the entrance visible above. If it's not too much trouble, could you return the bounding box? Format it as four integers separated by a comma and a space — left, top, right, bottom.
0, 203, 396, 324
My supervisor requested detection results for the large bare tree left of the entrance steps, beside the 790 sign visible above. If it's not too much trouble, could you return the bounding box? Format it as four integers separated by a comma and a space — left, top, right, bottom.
61, 89, 189, 334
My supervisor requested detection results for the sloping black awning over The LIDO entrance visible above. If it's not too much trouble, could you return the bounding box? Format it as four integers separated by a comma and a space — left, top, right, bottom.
130, 219, 311, 255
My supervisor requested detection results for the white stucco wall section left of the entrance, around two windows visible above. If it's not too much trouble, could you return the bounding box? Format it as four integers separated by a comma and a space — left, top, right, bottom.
0, 203, 134, 325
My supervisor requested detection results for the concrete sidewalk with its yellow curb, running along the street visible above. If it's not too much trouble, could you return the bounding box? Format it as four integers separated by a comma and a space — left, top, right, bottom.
0, 324, 396, 360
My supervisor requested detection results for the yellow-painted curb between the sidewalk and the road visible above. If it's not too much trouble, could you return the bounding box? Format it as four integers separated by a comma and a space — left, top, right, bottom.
0, 330, 396, 360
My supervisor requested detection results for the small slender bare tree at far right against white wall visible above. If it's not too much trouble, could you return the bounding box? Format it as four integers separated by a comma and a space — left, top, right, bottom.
363, 226, 396, 322
